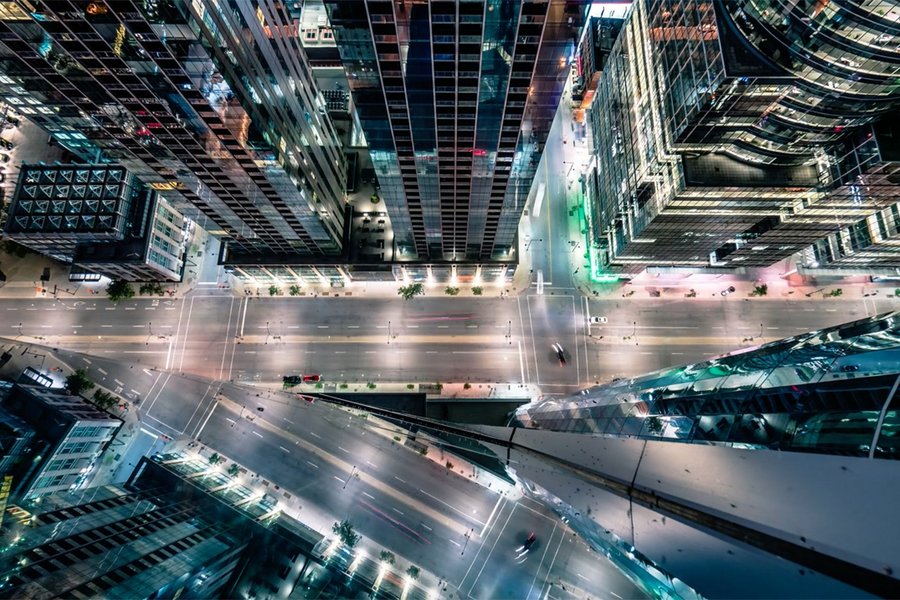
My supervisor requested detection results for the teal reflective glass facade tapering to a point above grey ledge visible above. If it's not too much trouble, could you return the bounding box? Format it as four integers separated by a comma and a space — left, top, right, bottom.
516, 313, 900, 459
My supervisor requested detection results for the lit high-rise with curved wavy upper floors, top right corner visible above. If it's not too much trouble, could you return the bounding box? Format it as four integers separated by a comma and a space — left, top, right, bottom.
588, 0, 900, 271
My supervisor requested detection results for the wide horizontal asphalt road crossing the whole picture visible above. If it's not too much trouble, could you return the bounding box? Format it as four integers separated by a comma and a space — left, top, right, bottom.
0, 288, 897, 393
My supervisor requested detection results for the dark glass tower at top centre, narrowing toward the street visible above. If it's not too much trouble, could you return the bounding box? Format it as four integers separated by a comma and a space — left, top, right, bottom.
325, 0, 587, 261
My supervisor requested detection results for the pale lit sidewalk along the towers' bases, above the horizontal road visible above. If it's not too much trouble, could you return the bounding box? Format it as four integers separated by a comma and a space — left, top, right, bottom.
0, 231, 900, 302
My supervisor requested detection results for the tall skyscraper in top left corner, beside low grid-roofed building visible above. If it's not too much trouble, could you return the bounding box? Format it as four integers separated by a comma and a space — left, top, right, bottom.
0, 0, 345, 260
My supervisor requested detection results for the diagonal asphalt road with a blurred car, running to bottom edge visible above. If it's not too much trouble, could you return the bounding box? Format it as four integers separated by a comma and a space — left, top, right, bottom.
42, 351, 642, 599
